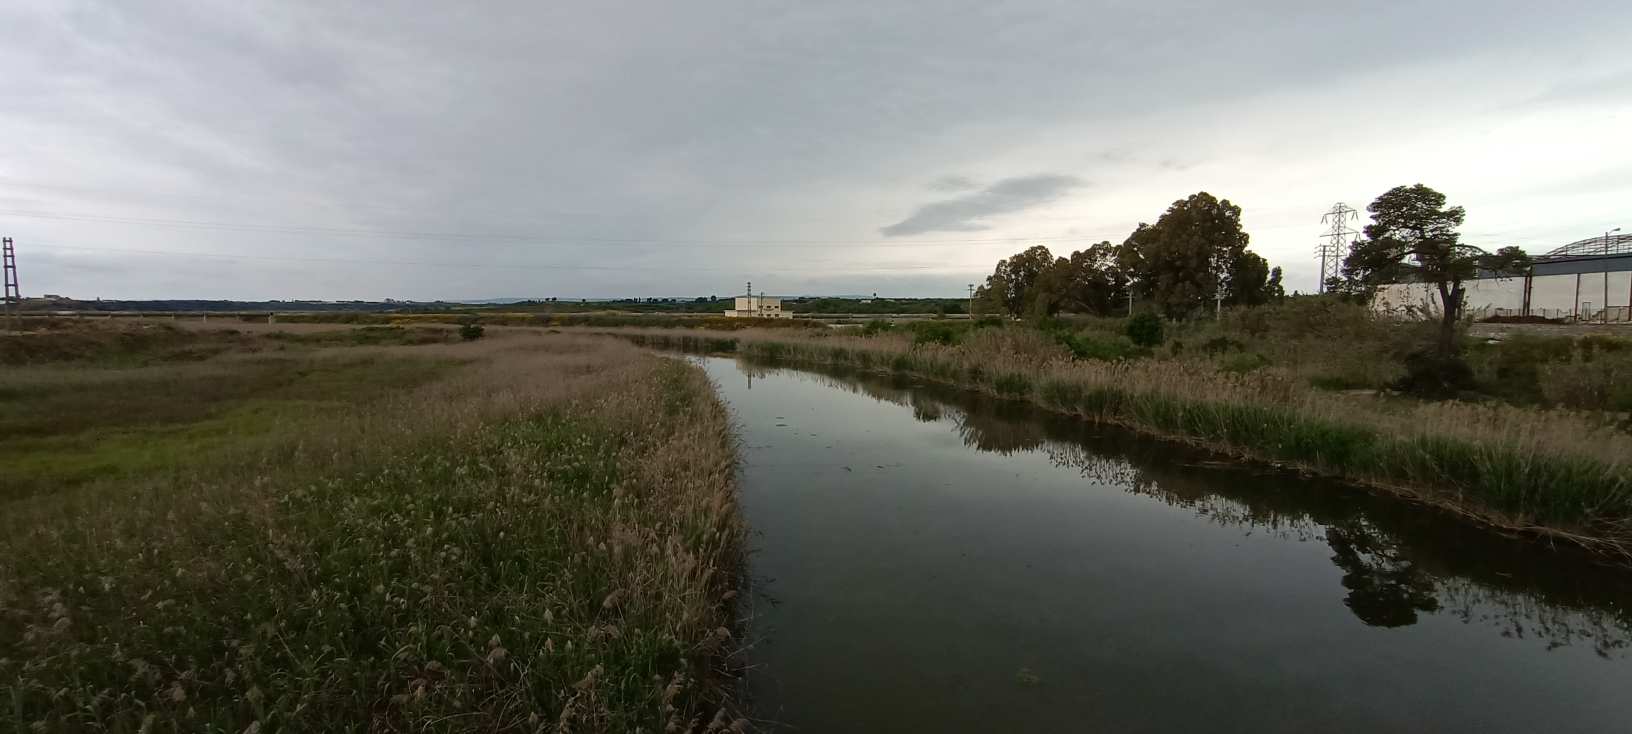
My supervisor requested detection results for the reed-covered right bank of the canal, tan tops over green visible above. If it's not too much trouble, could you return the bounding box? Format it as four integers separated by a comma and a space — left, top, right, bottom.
609, 329, 1632, 563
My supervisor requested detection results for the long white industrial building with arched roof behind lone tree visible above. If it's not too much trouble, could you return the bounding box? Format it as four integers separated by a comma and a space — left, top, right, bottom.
1373, 235, 1632, 323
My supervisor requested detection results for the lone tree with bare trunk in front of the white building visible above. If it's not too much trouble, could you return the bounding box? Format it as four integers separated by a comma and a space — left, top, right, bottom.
1343, 184, 1529, 360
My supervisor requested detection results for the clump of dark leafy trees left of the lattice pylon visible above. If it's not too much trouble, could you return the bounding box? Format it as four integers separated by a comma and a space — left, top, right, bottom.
974, 191, 1286, 318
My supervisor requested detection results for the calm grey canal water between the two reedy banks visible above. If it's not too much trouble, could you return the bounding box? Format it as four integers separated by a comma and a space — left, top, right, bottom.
700, 357, 1632, 732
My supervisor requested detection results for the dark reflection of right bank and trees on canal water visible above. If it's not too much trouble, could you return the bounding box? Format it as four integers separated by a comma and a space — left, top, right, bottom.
738, 359, 1632, 657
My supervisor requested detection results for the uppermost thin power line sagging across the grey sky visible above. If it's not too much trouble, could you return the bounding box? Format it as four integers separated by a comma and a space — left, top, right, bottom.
0, 210, 1085, 248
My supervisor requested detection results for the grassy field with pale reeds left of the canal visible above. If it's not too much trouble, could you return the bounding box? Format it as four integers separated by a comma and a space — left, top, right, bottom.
0, 328, 743, 732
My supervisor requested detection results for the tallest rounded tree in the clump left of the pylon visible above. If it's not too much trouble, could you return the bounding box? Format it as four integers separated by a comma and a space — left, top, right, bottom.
1116, 191, 1268, 318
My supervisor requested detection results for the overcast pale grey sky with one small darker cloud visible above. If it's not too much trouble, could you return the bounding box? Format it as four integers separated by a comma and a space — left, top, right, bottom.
0, 0, 1632, 300
